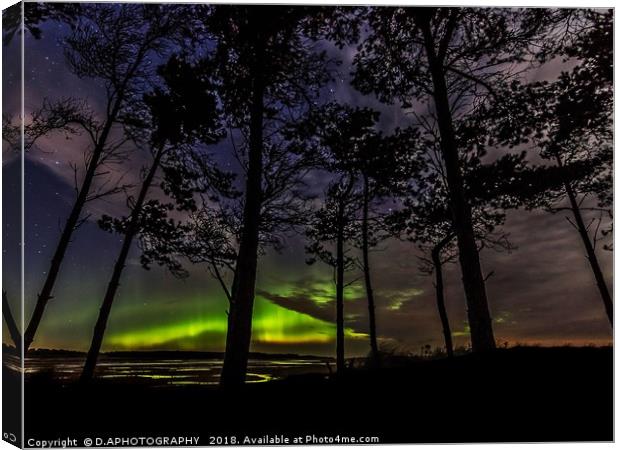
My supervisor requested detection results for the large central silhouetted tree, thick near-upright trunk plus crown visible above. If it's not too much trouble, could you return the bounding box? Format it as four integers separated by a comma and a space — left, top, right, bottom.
180, 5, 329, 386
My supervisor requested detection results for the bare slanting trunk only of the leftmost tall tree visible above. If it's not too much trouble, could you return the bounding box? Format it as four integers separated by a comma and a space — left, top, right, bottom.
24, 100, 120, 354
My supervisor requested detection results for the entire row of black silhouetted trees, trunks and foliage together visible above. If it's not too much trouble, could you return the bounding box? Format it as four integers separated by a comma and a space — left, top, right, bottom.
3, 3, 613, 386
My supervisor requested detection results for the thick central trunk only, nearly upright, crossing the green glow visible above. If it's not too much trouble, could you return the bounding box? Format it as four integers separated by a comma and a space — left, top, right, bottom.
220, 33, 265, 387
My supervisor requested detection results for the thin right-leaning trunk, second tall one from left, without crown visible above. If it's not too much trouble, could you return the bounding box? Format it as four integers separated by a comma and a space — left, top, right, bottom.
80, 145, 164, 383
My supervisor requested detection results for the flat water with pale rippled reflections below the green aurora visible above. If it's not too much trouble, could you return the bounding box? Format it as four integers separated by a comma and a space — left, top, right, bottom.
4, 355, 329, 386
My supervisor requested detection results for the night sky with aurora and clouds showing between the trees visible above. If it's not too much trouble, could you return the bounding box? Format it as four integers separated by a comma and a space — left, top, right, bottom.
3, 7, 612, 356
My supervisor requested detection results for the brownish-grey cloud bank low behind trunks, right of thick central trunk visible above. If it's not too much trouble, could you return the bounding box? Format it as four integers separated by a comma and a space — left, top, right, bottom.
257, 202, 612, 351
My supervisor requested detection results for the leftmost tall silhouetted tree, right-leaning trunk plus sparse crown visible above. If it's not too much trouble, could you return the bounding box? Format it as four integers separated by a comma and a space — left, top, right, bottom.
24, 5, 184, 351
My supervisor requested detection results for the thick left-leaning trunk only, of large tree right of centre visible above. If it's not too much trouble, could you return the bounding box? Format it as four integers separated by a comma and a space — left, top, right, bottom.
419, 20, 495, 352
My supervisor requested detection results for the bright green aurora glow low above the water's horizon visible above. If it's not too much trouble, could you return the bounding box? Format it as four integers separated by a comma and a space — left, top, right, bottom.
12, 260, 368, 354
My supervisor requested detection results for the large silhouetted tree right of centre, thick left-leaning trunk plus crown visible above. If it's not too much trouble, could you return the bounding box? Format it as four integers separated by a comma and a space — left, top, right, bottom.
353, 7, 560, 351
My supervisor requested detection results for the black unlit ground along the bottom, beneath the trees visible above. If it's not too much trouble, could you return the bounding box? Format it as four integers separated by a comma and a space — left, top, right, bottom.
12, 347, 613, 445
